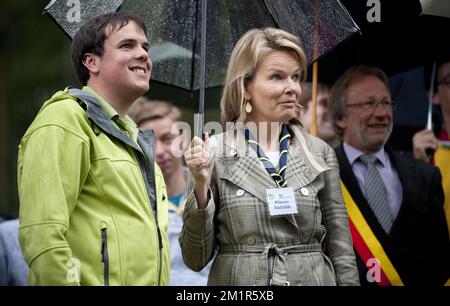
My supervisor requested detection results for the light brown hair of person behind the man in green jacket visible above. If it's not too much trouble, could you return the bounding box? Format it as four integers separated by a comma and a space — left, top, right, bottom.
128, 96, 181, 126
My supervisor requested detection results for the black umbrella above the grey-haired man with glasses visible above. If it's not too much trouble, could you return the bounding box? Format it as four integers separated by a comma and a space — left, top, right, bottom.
319, 0, 450, 83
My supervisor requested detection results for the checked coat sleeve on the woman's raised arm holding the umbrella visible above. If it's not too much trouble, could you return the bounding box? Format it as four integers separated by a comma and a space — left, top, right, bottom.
179, 164, 220, 272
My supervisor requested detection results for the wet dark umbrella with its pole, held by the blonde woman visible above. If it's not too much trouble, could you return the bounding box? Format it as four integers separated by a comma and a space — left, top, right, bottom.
45, 0, 359, 135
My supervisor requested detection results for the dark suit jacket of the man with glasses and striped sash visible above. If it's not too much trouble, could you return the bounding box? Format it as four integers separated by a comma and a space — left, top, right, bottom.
336, 144, 450, 286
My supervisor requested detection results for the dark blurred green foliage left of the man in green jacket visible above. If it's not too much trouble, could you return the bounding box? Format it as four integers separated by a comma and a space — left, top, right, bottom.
0, 0, 76, 218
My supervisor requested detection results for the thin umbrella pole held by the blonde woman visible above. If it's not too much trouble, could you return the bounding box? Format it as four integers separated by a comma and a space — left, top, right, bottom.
196, 0, 207, 138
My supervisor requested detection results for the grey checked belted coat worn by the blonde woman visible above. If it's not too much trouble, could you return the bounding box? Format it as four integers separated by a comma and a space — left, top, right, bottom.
180, 124, 359, 286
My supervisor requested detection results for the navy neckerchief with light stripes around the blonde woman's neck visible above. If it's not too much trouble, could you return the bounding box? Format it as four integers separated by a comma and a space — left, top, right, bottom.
244, 124, 291, 187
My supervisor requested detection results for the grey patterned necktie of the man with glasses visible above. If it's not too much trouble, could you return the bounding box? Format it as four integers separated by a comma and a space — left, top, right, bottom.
359, 155, 392, 234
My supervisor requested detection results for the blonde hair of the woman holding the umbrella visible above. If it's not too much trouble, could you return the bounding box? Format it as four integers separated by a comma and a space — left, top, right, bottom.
220, 28, 307, 126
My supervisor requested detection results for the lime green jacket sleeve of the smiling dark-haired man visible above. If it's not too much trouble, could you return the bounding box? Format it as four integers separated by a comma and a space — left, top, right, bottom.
18, 125, 89, 285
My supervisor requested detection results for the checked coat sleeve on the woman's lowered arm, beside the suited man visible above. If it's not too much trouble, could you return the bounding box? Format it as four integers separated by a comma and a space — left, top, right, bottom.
319, 145, 359, 286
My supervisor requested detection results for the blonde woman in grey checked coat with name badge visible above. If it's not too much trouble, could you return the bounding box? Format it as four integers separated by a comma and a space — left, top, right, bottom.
180, 28, 359, 286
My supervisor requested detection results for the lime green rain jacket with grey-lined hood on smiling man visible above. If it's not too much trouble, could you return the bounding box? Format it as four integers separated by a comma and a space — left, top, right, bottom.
18, 87, 170, 285
